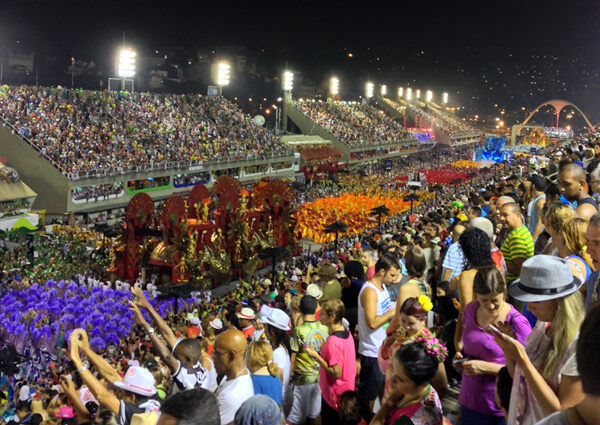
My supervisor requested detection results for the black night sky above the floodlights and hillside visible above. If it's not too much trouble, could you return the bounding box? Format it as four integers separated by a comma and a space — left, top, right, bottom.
0, 0, 600, 117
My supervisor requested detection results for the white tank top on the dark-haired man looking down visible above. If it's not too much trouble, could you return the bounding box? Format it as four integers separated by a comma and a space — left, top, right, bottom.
358, 282, 392, 358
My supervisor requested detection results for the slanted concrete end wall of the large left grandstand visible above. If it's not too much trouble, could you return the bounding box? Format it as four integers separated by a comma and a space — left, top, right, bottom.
0, 126, 69, 213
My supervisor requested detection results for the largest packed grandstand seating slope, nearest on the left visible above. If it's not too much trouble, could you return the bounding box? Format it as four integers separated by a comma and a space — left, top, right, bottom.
0, 86, 290, 178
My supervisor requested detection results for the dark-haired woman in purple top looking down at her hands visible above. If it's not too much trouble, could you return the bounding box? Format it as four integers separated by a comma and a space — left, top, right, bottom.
454, 266, 531, 425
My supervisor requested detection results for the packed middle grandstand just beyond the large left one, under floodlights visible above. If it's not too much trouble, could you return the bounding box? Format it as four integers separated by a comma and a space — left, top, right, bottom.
292, 99, 413, 147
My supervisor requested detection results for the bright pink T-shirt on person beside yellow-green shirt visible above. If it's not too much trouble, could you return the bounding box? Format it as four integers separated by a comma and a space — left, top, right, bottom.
319, 331, 356, 410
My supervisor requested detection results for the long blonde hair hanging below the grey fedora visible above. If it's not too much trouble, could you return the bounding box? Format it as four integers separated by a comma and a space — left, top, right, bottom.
538, 291, 585, 378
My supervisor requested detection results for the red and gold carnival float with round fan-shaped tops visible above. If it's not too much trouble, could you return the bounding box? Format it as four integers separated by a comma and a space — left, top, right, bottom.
108, 176, 297, 288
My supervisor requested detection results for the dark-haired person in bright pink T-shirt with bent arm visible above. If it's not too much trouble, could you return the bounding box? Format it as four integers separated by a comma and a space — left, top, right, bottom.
304, 300, 356, 425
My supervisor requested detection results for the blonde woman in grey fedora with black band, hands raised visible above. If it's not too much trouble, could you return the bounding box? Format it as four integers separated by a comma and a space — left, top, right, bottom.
491, 255, 585, 425
